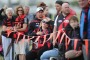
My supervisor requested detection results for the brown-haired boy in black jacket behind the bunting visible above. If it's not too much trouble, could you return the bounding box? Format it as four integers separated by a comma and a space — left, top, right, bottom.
65, 16, 83, 60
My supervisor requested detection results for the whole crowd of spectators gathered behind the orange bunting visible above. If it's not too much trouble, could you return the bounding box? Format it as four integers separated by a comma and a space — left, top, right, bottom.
0, 0, 90, 60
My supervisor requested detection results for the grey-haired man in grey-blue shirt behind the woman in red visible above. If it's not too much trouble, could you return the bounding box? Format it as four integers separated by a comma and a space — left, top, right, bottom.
24, 6, 34, 24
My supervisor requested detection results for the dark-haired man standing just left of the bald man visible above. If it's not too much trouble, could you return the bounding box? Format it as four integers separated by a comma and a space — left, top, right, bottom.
53, 1, 63, 44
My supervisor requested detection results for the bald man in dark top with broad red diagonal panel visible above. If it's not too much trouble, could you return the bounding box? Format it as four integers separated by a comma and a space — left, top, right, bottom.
53, 2, 76, 45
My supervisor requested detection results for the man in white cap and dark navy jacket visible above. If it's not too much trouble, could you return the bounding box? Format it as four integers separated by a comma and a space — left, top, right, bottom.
28, 7, 43, 35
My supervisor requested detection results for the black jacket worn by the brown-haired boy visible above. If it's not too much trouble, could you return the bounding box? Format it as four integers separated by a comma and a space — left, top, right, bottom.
65, 24, 80, 39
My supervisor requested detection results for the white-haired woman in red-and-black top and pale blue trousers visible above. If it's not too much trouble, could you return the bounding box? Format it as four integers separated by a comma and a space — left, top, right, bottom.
2, 8, 15, 60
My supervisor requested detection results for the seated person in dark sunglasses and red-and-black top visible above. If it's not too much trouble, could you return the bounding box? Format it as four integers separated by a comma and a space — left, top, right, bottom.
26, 19, 51, 60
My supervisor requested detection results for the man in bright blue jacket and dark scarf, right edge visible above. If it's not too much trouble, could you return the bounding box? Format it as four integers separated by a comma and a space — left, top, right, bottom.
78, 0, 89, 39
